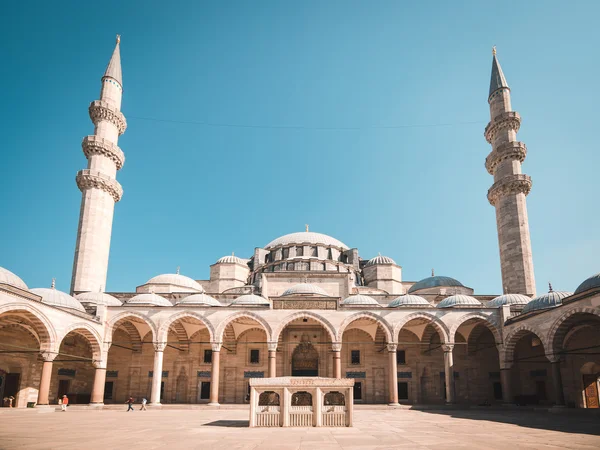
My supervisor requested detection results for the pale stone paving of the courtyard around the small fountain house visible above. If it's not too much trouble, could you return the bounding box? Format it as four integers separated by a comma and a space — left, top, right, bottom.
0, 406, 600, 450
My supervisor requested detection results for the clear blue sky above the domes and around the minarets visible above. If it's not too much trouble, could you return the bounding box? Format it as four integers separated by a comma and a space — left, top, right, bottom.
0, 1, 600, 294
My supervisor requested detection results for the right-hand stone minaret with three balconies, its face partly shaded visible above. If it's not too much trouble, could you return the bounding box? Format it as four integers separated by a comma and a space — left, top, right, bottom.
485, 47, 535, 295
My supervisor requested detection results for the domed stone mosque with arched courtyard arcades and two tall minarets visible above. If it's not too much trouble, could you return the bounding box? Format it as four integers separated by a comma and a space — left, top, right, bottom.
0, 38, 600, 408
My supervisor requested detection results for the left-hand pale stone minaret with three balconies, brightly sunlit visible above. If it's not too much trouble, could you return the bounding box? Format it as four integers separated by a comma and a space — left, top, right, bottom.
71, 36, 127, 294
